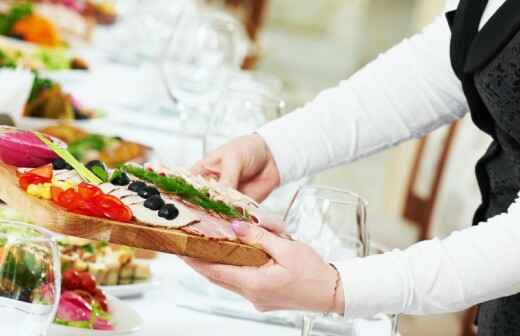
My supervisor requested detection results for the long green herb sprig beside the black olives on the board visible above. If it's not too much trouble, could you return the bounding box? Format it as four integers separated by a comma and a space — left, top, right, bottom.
121, 165, 251, 220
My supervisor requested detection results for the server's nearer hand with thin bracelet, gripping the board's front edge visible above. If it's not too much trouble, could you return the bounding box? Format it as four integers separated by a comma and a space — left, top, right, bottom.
183, 217, 345, 314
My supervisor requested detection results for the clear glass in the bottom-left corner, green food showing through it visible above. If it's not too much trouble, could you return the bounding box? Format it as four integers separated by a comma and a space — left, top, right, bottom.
0, 220, 61, 336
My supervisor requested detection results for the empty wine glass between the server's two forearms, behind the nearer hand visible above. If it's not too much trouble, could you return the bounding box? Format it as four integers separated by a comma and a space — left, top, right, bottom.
284, 185, 370, 336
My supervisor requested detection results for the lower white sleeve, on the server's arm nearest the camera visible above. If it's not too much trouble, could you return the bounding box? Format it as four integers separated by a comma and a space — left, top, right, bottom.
335, 192, 520, 317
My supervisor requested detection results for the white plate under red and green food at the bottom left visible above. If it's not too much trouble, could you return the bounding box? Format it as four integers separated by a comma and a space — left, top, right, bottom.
48, 296, 144, 336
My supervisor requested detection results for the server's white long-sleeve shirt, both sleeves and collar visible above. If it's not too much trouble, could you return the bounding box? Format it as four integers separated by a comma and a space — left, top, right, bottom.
258, 0, 520, 317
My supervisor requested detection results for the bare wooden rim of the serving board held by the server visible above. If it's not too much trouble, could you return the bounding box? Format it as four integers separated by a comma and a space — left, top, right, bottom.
0, 163, 269, 266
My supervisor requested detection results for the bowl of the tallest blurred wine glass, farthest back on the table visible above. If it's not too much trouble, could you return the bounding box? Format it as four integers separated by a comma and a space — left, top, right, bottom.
160, 9, 246, 121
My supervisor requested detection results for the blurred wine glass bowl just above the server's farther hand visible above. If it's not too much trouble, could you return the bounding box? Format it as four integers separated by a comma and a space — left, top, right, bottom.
203, 88, 285, 155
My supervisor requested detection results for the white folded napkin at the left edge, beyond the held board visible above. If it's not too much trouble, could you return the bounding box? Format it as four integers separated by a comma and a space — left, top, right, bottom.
0, 69, 34, 119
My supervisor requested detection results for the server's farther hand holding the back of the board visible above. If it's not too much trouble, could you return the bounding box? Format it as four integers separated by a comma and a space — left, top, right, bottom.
192, 134, 280, 202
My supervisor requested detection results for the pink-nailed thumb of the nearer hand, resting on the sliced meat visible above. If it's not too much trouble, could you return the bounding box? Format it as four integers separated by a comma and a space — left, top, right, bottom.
231, 221, 291, 263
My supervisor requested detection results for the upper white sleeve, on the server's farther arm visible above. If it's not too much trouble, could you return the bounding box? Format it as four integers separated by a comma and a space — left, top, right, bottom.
258, 17, 467, 183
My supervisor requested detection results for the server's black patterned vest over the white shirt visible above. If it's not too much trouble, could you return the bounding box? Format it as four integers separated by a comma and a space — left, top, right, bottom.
447, 0, 520, 336
